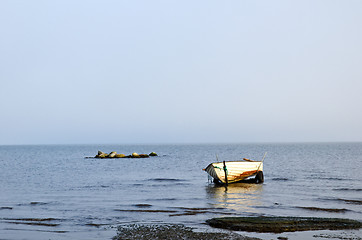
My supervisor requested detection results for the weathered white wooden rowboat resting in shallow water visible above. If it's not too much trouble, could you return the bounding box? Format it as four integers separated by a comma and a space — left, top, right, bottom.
204, 153, 266, 184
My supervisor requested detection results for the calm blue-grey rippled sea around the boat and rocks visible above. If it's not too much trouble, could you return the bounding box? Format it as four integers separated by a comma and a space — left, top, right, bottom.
0, 142, 362, 240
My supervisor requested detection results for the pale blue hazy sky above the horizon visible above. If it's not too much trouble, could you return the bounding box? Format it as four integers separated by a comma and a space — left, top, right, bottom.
0, 0, 362, 145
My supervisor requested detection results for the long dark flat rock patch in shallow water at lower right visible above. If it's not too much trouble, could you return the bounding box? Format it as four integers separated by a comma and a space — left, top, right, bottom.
206, 217, 362, 233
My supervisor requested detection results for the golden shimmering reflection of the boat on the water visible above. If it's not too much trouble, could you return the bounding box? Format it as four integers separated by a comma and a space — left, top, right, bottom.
206, 183, 263, 214
